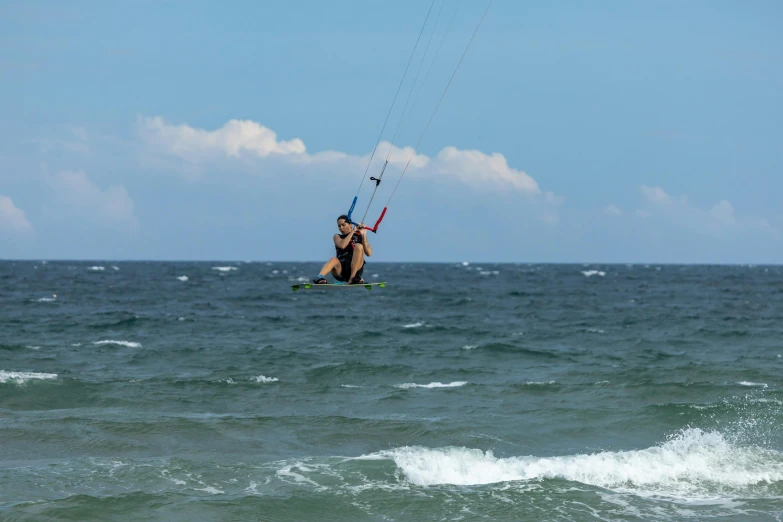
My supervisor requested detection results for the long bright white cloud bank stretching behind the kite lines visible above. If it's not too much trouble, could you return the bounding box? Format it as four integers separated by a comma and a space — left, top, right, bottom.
138, 116, 562, 197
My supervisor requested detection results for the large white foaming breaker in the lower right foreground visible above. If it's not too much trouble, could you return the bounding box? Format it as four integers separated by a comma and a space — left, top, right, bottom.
380, 429, 783, 500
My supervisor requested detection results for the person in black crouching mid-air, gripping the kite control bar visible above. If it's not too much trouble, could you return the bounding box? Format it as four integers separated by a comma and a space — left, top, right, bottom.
313, 214, 372, 285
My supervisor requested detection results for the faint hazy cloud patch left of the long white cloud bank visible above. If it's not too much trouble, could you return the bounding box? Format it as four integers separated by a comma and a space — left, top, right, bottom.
48, 170, 138, 227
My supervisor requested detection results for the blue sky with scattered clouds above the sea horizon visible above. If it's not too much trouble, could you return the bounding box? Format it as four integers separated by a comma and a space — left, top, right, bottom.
0, 0, 783, 264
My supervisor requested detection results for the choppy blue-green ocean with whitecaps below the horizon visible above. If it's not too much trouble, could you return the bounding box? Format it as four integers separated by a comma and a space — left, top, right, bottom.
0, 261, 783, 521
